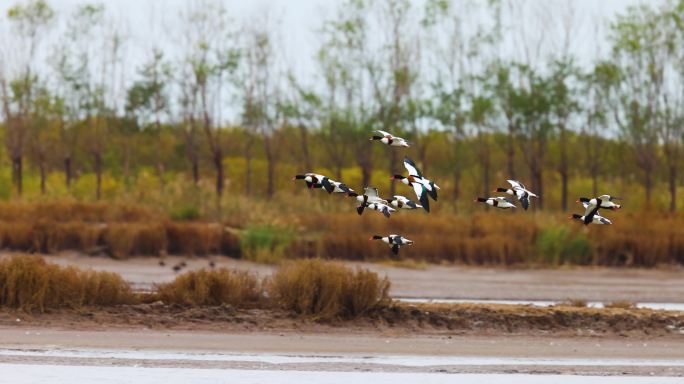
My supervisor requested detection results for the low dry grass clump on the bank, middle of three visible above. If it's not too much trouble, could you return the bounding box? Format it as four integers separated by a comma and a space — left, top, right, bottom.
157, 268, 264, 308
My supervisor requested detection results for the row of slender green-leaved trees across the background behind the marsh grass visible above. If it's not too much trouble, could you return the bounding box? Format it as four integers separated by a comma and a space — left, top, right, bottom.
0, 0, 684, 211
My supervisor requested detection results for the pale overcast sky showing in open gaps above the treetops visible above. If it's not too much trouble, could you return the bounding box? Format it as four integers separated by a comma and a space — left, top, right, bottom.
0, 0, 660, 122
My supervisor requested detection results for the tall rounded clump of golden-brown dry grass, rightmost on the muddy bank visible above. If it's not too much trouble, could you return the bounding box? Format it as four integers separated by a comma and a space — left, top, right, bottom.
268, 260, 390, 320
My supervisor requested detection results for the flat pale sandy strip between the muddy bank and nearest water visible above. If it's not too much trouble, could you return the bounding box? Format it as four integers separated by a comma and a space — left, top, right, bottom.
0, 327, 684, 376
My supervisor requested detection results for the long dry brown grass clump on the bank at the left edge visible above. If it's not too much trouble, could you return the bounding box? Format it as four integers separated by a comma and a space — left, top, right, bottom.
0, 255, 135, 312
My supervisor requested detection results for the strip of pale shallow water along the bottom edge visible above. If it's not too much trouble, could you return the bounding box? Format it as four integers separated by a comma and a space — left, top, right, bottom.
0, 363, 682, 384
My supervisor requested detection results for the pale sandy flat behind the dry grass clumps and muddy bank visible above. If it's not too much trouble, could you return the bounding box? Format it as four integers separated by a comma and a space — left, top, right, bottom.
32, 253, 684, 303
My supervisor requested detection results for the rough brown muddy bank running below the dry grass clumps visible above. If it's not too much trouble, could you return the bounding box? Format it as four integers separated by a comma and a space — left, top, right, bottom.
0, 303, 684, 338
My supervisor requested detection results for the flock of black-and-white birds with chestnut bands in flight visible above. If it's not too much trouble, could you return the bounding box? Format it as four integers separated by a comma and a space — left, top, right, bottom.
293, 131, 621, 255
